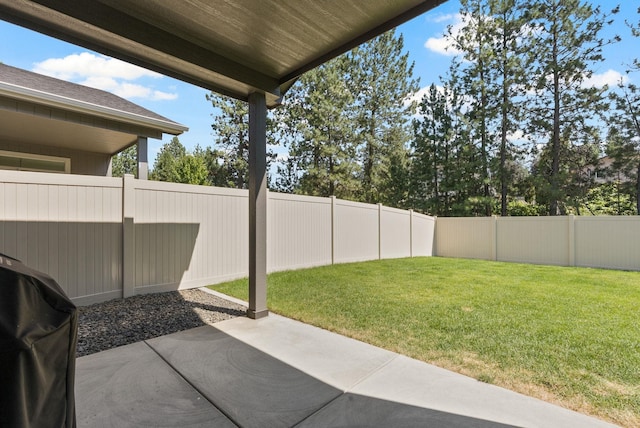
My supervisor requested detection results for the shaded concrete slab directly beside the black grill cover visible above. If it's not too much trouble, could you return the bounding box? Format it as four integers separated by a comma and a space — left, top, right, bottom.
75, 342, 235, 428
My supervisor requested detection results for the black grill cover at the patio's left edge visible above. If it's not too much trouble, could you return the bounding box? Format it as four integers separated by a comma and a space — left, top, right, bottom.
0, 254, 78, 428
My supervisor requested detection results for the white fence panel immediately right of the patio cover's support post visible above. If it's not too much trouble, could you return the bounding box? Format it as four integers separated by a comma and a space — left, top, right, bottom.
267, 192, 332, 272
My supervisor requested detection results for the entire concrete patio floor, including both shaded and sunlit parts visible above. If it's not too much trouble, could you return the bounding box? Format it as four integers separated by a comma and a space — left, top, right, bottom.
76, 314, 613, 428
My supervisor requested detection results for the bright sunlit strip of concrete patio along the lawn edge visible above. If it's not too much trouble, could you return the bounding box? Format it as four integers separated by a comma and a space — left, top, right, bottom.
211, 314, 612, 427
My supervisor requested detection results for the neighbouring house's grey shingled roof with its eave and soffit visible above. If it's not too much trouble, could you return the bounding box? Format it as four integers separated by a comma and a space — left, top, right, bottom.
0, 64, 188, 154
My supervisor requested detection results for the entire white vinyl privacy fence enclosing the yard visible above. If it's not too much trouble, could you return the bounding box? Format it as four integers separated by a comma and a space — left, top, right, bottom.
0, 171, 640, 305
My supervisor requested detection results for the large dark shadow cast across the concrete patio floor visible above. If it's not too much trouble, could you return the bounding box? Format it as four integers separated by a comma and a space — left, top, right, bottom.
76, 326, 508, 427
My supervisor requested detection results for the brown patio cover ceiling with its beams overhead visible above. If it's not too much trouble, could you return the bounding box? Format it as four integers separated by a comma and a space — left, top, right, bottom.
0, 0, 445, 107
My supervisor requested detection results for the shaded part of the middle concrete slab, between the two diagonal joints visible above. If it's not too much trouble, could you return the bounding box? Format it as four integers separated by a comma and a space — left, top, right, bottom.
147, 326, 342, 428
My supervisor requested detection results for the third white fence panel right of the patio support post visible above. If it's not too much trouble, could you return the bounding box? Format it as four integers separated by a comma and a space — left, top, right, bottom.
380, 206, 412, 259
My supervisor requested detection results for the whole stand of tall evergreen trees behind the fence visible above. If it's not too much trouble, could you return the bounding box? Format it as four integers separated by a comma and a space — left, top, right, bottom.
122, 0, 640, 216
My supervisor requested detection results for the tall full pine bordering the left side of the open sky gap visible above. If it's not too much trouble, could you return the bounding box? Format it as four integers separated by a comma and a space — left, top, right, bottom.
347, 30, 418, 203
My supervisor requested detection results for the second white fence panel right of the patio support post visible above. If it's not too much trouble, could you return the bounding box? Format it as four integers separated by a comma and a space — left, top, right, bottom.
333, 199, 380, 263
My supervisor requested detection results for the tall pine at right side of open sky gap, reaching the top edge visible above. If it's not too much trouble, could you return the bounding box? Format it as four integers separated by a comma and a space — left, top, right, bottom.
448, 0, 527, 215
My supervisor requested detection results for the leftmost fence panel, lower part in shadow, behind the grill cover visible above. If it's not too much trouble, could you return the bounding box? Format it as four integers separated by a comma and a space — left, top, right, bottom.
0, 171, 122, 303
